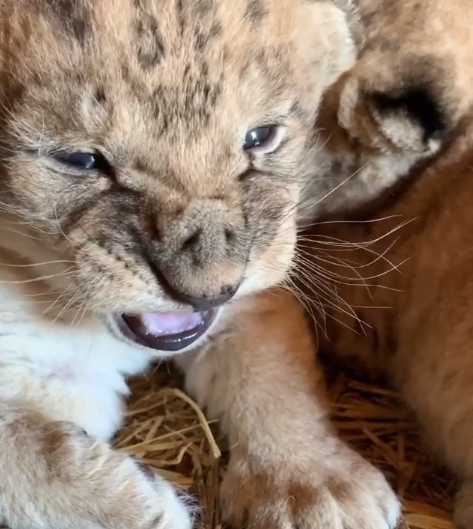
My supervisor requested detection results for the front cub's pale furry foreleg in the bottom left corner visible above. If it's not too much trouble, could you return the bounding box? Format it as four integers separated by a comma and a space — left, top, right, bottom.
0, 396, 192, 529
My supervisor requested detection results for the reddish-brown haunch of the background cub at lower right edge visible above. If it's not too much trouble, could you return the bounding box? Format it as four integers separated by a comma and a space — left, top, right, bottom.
393, 310, 473, 529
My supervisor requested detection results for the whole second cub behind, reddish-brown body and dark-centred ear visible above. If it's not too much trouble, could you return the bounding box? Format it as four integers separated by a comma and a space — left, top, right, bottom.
299, 0, 473, 529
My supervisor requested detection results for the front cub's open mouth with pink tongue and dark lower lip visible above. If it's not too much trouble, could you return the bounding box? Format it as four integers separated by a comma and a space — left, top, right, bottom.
106, 307, 224, 358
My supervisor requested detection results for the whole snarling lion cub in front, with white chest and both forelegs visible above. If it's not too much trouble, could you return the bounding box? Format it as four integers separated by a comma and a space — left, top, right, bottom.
0, 0, 399, 529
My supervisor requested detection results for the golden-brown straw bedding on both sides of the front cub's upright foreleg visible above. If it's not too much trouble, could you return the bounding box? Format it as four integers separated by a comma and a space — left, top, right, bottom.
114, 369, 454, 529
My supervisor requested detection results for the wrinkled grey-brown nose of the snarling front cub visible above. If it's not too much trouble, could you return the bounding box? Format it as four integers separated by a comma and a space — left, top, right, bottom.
153, 200, 250, 311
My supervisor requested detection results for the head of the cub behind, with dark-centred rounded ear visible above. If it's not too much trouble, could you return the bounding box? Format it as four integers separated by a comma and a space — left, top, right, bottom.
300, 0, 473, 217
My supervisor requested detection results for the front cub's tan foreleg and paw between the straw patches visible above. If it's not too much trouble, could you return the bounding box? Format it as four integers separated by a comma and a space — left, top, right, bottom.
175, 291, 400, 529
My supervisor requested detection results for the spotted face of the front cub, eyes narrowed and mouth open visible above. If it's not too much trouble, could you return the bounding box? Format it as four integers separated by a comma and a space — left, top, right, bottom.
0, 0, 353, 351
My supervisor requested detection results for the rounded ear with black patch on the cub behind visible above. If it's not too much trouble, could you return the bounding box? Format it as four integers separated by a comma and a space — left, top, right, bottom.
338, 49, 459, 156
